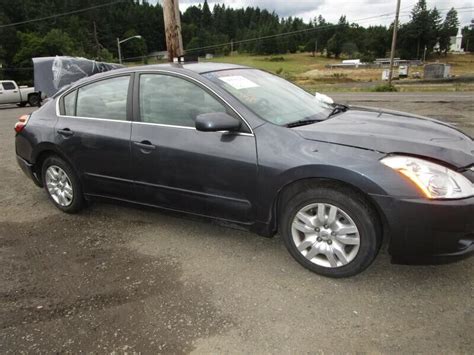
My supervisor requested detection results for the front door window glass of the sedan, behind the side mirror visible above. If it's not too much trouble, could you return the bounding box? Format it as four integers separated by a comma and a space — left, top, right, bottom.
139, 74, 226, 127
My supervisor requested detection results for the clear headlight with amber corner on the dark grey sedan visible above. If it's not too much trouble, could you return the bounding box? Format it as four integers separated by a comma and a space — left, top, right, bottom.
381, 155, 474, 199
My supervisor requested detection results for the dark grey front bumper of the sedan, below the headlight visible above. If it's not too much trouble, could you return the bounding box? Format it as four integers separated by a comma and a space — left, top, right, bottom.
372, 195, 474, 264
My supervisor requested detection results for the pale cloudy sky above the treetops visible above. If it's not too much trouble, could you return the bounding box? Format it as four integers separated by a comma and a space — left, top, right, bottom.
156, 0, 474, 26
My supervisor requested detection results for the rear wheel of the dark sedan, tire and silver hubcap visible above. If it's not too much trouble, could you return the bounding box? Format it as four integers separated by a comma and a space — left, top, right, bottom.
41, 156, 85, 213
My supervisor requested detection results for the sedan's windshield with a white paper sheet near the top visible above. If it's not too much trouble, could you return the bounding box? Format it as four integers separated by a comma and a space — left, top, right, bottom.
203, 69, 332, 126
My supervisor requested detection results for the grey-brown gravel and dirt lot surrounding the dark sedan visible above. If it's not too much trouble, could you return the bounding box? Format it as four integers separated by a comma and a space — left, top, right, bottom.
0, 94, 474, 353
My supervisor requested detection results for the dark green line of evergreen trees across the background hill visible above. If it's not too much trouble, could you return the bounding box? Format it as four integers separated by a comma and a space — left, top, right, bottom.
0, 0, 474, 82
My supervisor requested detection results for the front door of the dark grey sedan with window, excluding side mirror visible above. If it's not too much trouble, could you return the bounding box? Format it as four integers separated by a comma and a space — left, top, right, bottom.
131, 73, 257, 222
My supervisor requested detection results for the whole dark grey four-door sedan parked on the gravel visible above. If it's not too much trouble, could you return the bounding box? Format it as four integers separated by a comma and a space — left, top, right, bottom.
15, 63, 474, 277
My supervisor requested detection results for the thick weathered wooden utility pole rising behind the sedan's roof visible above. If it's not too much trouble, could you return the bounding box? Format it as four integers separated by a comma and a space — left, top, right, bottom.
163, 0, 184, 62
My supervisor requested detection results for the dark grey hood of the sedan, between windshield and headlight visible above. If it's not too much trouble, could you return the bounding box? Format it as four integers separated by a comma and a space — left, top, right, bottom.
293, 107, 474, 168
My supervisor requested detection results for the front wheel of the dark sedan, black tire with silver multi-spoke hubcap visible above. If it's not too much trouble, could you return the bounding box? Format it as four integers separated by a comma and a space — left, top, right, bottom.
279, 182, 382, 278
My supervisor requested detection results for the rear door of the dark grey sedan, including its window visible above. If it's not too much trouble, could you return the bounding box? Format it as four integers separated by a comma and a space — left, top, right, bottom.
55, 75, 133, 199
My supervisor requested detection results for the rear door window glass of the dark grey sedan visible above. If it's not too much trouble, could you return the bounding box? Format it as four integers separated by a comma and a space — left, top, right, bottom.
75, 76, 130, 121
